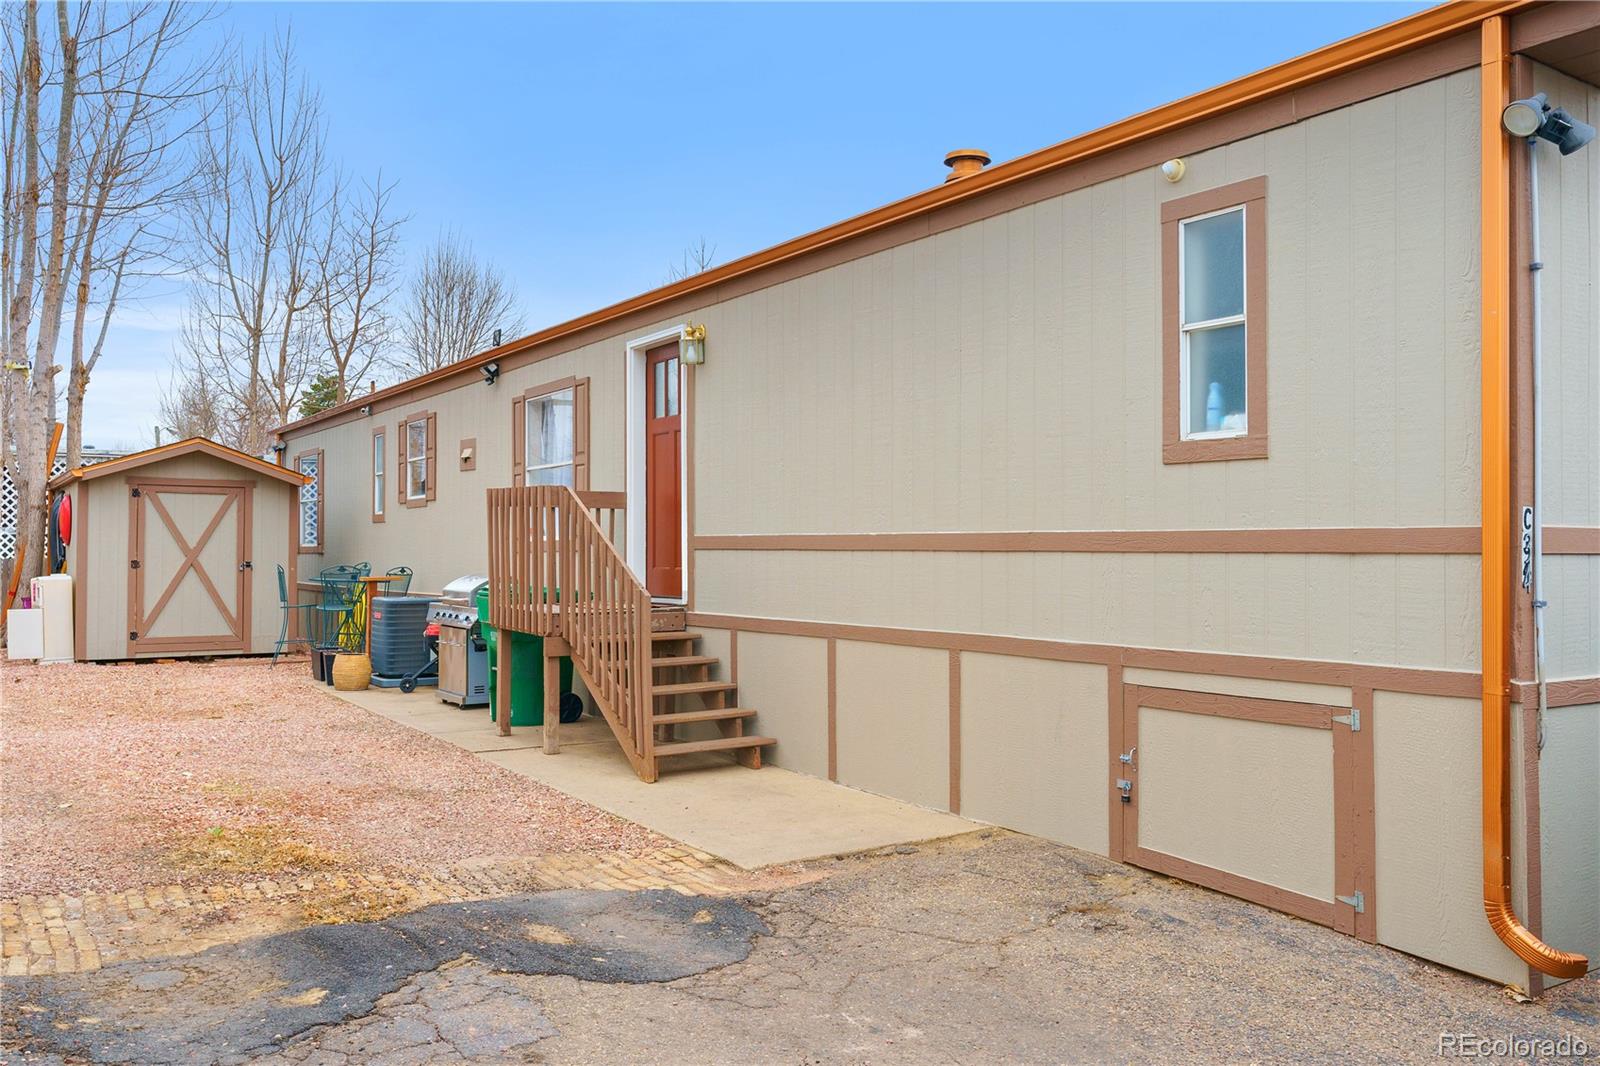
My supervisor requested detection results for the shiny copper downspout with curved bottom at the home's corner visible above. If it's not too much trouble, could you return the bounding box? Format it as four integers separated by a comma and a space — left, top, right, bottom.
1478, 16, 1589, 978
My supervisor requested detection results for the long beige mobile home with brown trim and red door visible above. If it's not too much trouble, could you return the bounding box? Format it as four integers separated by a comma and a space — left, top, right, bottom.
282, 3, 1600, 988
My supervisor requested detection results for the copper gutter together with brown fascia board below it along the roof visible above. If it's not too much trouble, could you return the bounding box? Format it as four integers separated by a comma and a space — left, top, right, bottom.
277, 2, 1534, 437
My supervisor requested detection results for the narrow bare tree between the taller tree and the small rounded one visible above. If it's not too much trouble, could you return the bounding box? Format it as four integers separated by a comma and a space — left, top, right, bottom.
314, 173, 405, 403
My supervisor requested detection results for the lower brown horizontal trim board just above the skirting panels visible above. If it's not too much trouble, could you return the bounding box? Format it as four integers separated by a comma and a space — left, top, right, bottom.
688, 611, 1482, 701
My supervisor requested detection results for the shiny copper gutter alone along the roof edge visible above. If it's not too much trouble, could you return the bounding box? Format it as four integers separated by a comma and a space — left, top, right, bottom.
274, 0, 1547, 437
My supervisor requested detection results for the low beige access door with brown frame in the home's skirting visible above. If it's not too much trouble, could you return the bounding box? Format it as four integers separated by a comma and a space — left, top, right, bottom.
1117, 685, 1376, 941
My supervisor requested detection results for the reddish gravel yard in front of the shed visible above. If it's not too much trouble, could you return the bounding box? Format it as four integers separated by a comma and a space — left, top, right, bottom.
0, 659, 669, 898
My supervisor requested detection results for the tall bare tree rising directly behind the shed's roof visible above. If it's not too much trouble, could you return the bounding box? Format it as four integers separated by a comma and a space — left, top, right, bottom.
181, 34, 330, 455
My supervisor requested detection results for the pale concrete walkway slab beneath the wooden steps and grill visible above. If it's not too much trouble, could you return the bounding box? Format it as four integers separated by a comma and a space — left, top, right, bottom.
324, 680, 979, 869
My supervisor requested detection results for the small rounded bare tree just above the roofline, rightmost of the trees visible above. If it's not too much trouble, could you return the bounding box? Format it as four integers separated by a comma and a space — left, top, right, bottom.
394, 232, 522, 375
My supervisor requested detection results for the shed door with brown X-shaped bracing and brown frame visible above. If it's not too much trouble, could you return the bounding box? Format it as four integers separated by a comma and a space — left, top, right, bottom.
128, 479, 251, 655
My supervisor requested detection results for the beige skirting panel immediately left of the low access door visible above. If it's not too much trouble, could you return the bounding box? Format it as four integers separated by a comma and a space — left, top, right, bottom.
962, 653, 1110, 855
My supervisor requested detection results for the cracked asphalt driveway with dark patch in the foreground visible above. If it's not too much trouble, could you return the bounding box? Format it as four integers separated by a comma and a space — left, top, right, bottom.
6, 832, 1600, 1064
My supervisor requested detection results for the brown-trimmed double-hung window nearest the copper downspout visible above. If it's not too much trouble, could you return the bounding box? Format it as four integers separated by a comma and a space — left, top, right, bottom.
1162, 178, 1267, 463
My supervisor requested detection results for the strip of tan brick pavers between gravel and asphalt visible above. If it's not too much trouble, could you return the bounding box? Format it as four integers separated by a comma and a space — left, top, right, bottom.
0, 847, 787, 976
